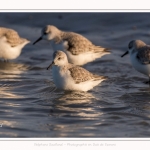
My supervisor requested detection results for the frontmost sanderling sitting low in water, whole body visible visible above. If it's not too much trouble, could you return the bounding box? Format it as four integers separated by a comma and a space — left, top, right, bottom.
47, 51, 107, 91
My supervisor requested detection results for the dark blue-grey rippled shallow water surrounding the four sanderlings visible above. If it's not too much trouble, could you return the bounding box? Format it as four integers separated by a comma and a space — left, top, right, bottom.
0, 13, 150, 138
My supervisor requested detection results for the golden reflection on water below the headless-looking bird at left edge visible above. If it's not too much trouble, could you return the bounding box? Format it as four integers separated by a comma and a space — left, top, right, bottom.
0, 61, 28, 98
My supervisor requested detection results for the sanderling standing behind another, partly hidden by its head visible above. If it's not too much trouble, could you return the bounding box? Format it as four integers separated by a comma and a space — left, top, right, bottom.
33, 25, 110, 65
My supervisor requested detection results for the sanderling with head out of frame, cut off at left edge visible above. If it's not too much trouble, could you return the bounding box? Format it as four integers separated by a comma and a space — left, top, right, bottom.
0, 27, 30, 61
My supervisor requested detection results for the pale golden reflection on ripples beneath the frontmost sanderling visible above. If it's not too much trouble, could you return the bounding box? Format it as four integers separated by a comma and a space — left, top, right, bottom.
44, 90, 102, 119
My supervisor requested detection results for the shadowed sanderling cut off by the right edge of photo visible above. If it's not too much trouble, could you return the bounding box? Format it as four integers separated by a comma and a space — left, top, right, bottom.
121, 40, 150, 84
